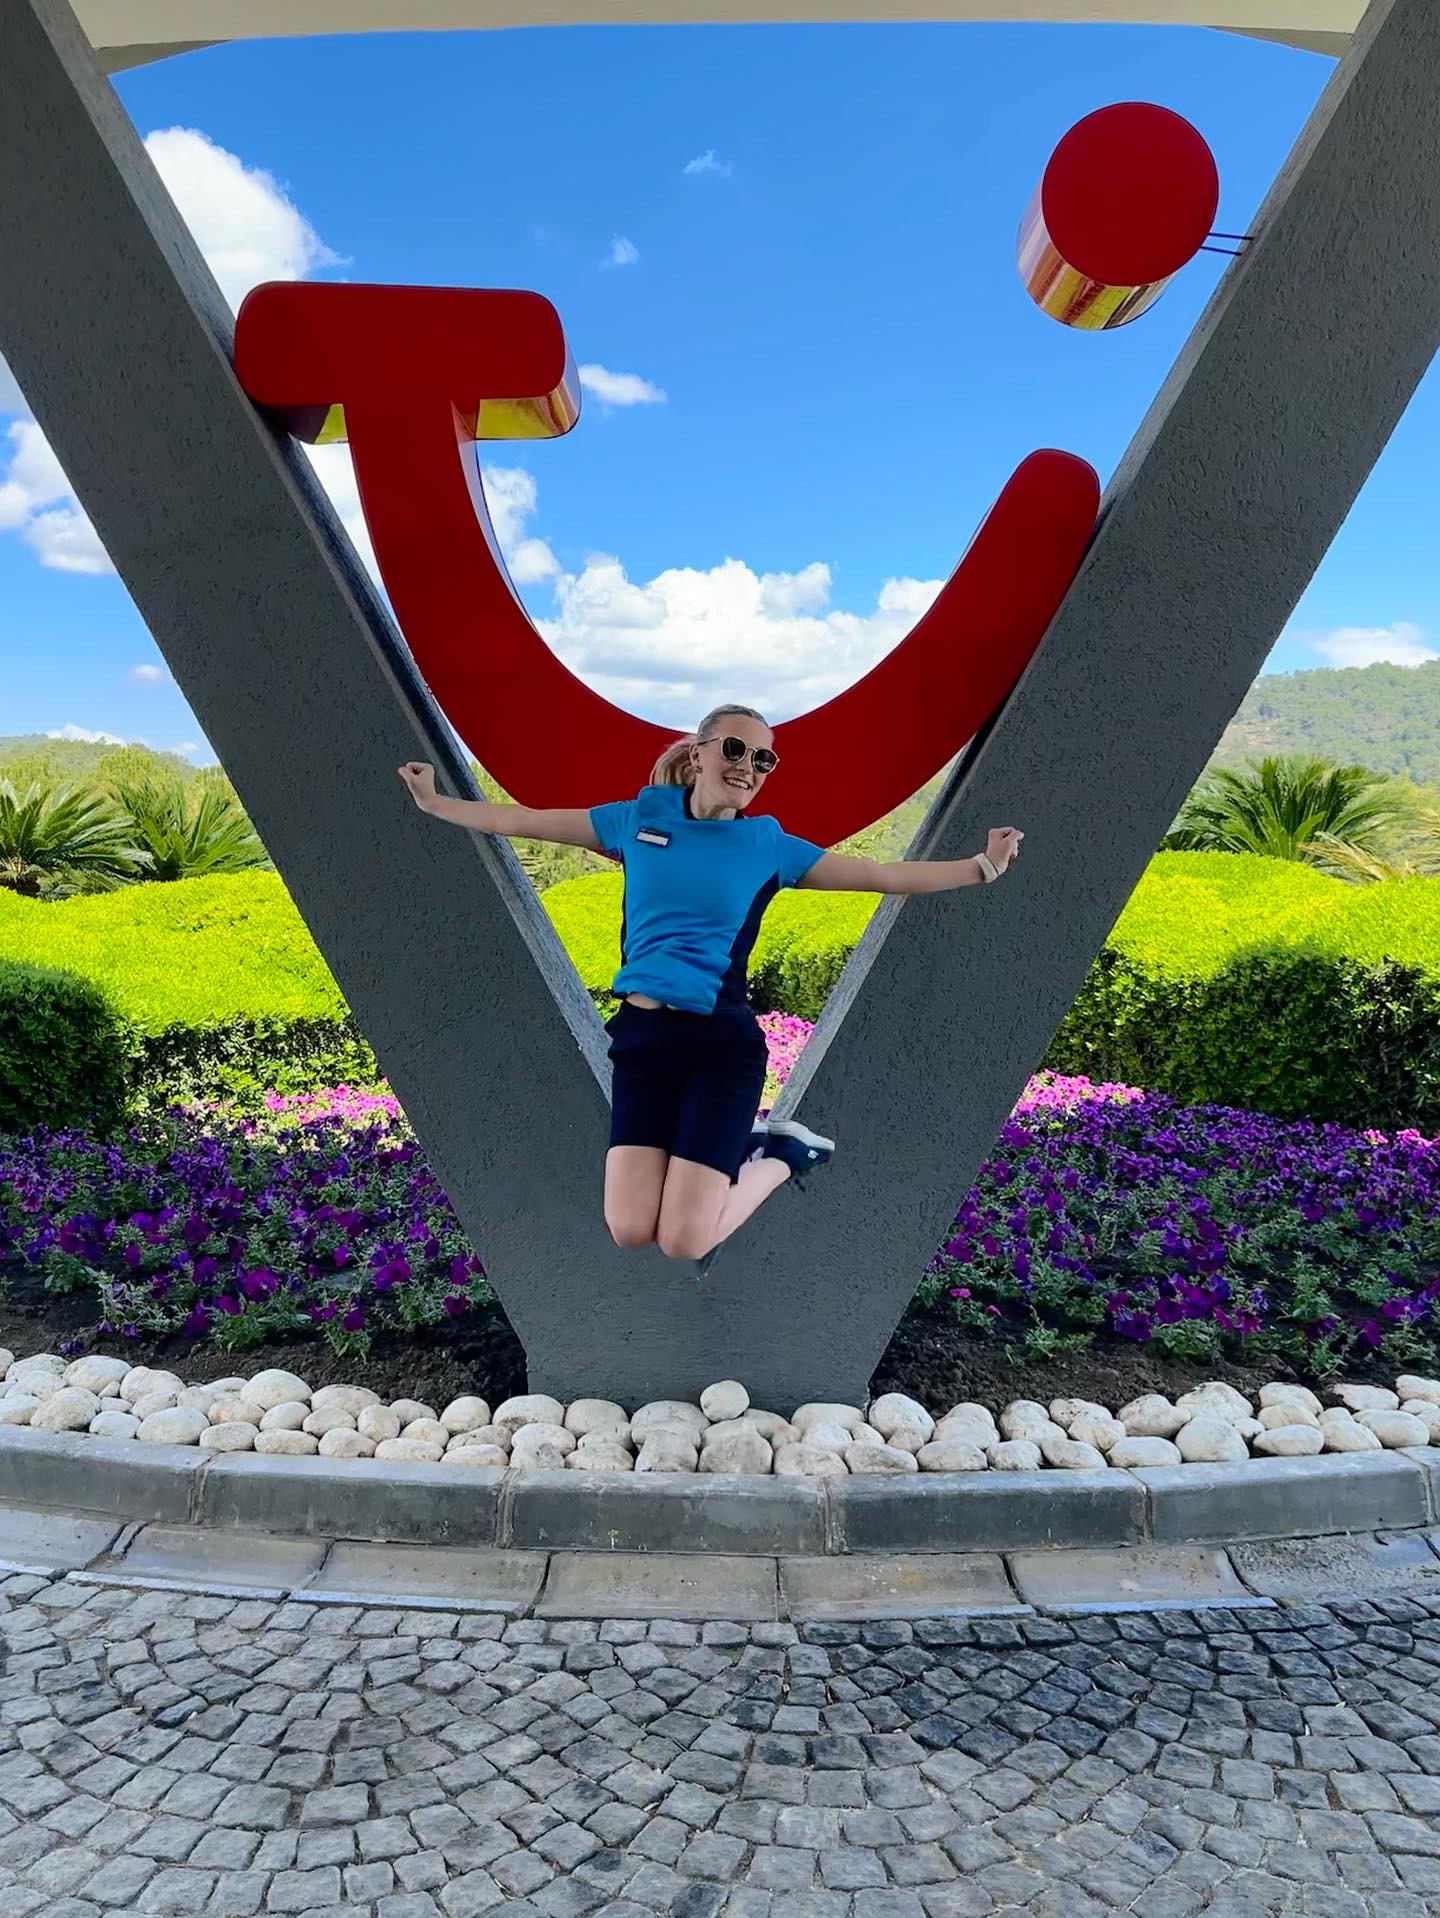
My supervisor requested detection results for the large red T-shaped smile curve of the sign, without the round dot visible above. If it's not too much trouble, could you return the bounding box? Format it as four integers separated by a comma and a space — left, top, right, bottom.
236, 280, 1099, 846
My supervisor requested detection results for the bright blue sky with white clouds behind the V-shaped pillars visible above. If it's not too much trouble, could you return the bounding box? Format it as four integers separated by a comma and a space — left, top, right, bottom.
0, 25, 1440, 760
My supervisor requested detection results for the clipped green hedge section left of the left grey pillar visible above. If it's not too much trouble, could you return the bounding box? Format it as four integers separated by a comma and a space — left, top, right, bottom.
0, 873, 378, 1132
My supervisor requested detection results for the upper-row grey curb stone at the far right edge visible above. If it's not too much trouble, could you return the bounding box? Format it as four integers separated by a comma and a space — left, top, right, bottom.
1135, 1452, 1428, 1544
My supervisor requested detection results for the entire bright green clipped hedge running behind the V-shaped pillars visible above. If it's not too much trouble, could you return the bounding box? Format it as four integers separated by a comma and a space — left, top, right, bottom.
0, 854, 1440, 1132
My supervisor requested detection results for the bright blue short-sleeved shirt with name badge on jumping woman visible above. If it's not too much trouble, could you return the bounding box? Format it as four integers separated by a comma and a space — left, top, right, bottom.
591, 786, 825, 1013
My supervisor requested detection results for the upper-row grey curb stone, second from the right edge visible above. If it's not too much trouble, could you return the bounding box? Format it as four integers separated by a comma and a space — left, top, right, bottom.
826, 1469, 1145, 1552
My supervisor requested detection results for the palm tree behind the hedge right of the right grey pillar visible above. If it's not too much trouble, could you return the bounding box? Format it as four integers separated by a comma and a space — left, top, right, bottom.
1160, 754, 1415, 867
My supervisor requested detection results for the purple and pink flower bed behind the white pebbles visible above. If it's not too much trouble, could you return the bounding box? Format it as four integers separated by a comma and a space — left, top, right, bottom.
0, 1015, 1440, 1377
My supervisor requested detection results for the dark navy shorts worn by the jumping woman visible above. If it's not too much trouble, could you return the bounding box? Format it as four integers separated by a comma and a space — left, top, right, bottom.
606, 999, 769, 1180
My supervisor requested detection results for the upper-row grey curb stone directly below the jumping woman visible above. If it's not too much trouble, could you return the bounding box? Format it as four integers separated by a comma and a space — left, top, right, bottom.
497, 1471, 826, 1555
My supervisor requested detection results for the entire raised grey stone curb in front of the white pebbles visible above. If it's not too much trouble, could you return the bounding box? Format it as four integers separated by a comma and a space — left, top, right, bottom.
0, 1425, 1440, 1557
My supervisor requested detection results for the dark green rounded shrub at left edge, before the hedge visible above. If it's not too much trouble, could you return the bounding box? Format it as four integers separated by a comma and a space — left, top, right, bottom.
0, 959, 132, 1132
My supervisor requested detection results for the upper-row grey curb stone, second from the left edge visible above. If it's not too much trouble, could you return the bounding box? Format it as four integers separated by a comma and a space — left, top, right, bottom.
195, 1439, 504, 1546
